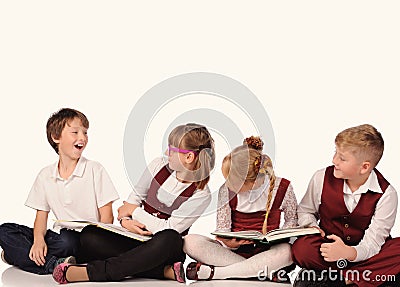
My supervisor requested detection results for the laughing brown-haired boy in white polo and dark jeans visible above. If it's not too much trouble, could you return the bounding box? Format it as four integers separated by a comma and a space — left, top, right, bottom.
0, 108, 119, 274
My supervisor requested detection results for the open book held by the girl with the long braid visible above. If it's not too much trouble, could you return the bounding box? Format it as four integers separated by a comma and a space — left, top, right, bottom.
211, 227, 319, 243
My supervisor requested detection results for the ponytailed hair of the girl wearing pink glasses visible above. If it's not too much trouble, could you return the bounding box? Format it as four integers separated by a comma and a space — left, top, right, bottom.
168, 123, 215, 189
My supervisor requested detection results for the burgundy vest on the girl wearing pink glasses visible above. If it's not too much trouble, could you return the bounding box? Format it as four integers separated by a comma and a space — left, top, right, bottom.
142, 165, 196, 235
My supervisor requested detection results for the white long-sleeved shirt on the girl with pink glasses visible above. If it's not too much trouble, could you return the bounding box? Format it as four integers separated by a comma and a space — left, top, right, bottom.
127, 157, 211, 234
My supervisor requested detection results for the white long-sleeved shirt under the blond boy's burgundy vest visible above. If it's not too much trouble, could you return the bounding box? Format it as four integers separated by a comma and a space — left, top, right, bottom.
298, 168, 397, 262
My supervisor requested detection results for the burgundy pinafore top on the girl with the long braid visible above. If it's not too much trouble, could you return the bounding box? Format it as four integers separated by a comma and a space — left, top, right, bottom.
229, 178, 290, 234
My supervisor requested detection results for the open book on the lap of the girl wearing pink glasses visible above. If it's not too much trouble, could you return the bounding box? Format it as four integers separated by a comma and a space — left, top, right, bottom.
54, 220, 151, 242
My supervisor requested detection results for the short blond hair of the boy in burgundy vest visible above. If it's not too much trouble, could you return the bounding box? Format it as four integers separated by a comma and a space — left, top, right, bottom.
335, 124, 384, 167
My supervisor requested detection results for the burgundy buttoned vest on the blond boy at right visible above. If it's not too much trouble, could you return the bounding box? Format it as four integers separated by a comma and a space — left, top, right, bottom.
319, 166, 390, 246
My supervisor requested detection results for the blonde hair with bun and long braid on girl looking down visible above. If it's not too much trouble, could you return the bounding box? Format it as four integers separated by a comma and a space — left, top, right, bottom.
222, 136, 276, 234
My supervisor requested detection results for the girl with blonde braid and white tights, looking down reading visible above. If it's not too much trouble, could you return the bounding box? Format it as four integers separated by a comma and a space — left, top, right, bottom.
183, 136, 297, 283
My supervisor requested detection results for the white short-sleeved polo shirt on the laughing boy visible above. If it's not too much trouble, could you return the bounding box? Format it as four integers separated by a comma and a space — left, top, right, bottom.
25, 157, 119, 230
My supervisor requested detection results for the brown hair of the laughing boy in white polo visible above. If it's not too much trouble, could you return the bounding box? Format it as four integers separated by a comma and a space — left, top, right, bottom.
46, 108, 89, 154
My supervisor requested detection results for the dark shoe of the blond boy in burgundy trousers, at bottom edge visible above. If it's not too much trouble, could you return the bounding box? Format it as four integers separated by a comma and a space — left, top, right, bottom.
293, 268, 346, 287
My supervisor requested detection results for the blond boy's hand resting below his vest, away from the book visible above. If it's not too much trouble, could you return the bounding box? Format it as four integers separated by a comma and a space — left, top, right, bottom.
319, 234, 357, 262
